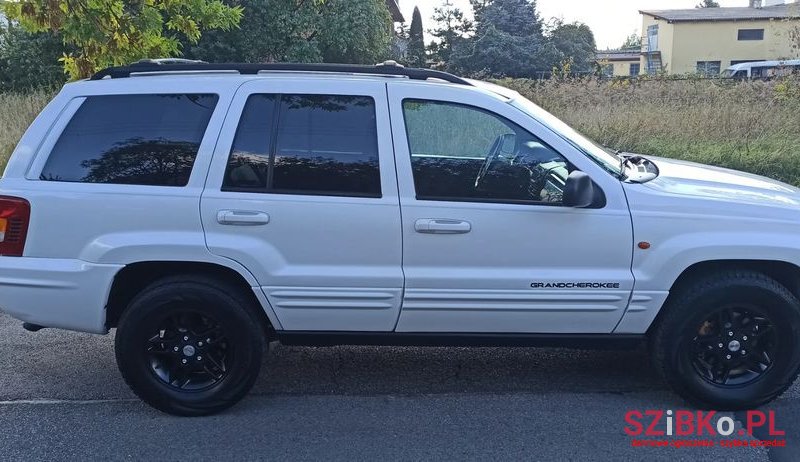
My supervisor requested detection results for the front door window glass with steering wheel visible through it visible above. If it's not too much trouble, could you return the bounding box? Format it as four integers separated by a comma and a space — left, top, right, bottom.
403, 100, 573, 205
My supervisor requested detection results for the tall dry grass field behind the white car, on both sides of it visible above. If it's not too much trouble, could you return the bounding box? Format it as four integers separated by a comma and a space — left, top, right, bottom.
0, 80, 800, 186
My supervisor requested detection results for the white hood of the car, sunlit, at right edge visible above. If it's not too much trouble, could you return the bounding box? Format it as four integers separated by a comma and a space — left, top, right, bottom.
644, 156, 800, 207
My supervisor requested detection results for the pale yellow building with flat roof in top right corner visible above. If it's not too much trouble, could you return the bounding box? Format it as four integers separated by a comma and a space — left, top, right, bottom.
640, 0, 800, 75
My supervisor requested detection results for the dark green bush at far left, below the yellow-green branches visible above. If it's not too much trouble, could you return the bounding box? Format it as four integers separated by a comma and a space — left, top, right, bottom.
0, 22, 67, 92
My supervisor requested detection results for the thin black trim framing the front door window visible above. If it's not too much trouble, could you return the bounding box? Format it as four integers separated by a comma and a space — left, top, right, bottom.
400, 97, 580, 209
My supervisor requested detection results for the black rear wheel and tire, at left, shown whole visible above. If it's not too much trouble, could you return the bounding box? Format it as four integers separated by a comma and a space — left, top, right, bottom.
115, 276, 266, 416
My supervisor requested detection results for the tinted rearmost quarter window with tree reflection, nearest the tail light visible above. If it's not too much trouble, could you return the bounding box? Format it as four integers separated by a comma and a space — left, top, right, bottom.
41, 94, 218, 186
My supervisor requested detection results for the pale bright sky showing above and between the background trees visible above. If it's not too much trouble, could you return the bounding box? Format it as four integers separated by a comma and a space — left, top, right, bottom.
399, 0, 749, 49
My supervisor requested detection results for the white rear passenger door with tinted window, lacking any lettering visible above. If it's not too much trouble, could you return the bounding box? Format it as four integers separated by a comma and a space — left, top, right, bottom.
201, 76, 403, 331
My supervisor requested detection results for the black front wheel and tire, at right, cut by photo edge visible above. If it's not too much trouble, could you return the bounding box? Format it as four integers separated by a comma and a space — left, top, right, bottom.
650, 271, 800, 411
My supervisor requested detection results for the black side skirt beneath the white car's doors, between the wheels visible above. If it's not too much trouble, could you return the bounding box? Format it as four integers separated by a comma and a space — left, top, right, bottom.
276, 331, 645, 350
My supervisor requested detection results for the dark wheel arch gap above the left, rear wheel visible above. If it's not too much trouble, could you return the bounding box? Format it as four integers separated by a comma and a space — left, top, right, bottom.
106, 261, 279, 338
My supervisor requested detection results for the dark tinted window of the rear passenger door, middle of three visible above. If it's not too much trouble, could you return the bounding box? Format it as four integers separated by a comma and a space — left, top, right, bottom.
223, 95, 381, 197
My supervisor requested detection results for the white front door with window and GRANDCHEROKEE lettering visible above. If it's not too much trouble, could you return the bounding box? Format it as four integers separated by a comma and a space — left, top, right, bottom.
389, 82, 633, 333
